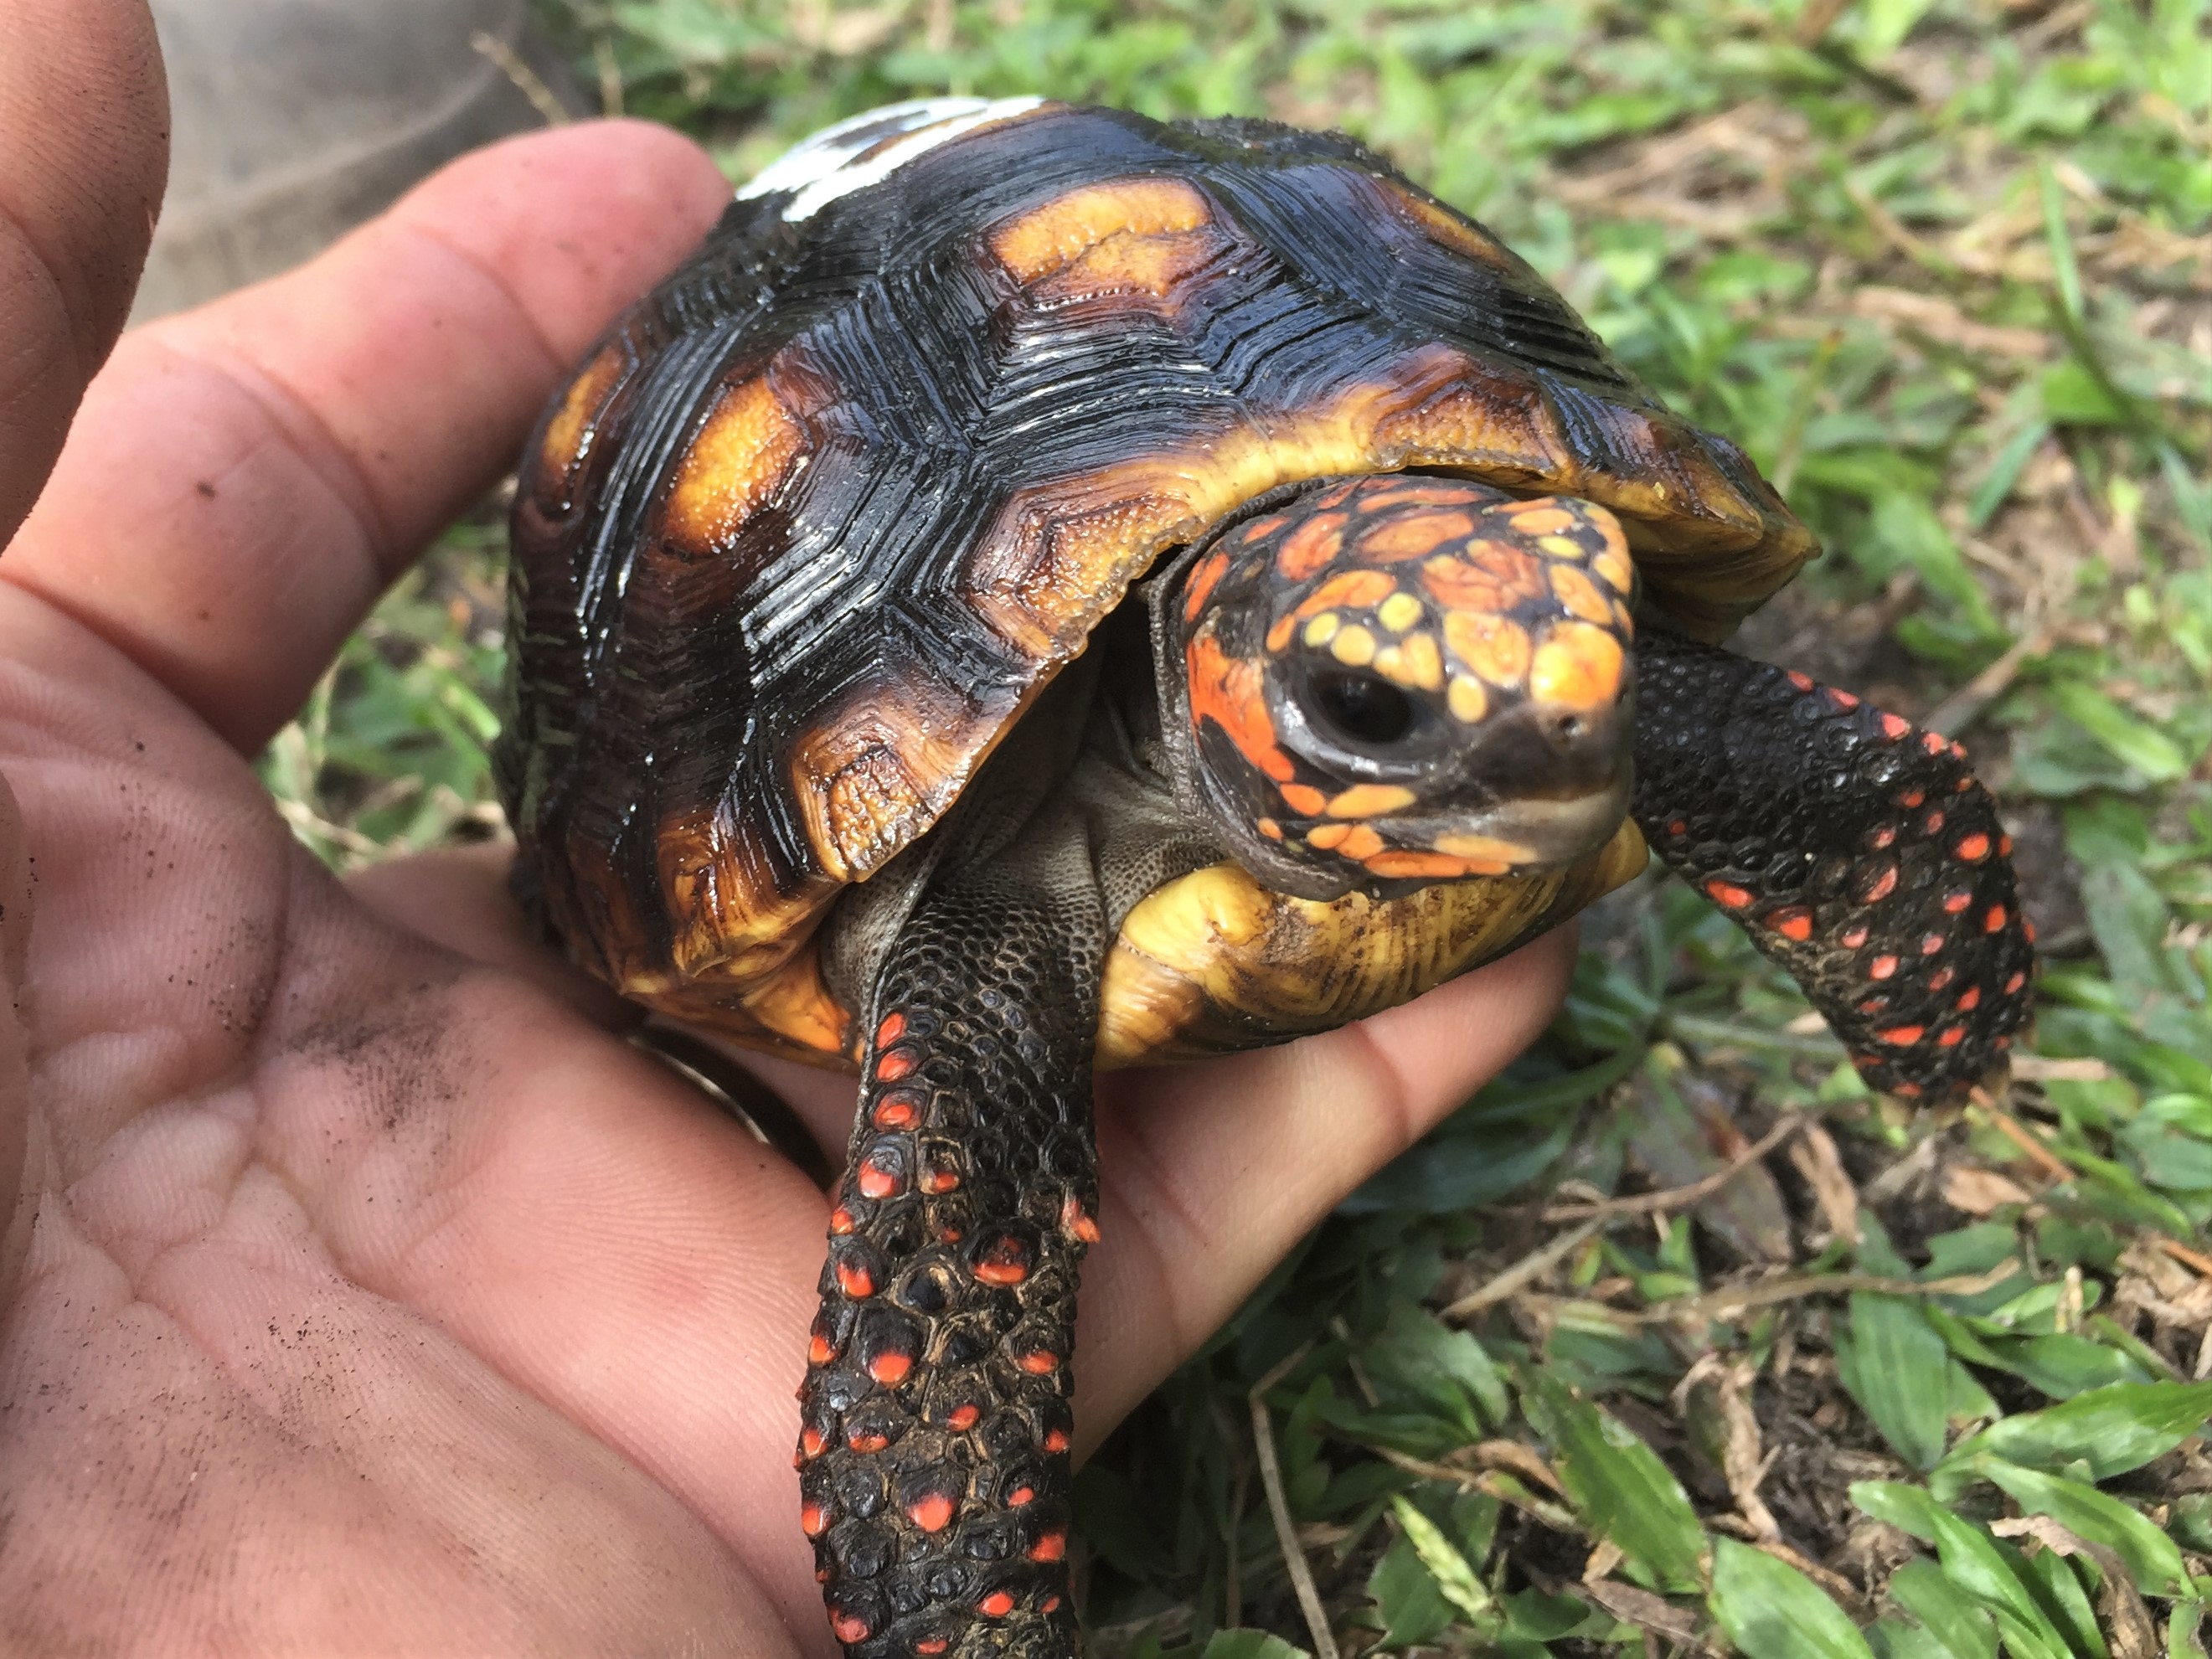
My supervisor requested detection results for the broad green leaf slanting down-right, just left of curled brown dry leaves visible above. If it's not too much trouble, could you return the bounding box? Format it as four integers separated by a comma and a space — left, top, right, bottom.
1522, 1369, 1705, 1590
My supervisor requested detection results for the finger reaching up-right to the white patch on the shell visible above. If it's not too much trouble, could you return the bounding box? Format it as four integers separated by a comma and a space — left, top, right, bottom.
0, 121, 730, 750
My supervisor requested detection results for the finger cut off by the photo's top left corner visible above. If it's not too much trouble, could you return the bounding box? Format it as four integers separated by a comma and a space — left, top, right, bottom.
0, 0, 168, 546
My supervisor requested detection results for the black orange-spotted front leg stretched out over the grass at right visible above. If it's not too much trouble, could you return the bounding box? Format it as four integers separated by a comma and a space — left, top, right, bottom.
1635, 626, 2035, 1100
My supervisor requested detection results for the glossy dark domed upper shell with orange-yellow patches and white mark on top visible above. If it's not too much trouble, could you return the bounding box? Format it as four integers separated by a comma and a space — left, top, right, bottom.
496, 100, 1816, 1055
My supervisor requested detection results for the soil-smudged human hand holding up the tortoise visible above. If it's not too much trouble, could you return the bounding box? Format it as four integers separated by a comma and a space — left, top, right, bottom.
0, 0, 1570, 1655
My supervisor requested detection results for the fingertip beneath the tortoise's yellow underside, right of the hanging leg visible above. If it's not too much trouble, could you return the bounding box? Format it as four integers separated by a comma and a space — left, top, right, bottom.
1075, 925, 1577, 1446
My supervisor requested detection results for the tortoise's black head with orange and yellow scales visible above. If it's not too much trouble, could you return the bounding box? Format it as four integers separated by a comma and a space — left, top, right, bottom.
1159, 476, 1635, 898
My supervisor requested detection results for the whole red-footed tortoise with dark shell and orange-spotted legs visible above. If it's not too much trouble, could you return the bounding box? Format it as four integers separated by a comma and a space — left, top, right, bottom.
498, 100, 2033, 1659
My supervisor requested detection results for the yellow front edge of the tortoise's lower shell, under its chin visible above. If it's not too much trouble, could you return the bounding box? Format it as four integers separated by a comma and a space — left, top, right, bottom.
1097, 823, 1646, 1066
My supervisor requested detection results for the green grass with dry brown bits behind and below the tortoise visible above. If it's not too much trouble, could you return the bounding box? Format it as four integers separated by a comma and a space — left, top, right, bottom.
268, 0, 2212, 1659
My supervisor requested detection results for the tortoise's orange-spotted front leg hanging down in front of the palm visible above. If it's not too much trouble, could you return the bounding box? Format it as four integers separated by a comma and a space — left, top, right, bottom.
798, 865, 1104, 1659
